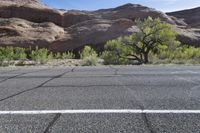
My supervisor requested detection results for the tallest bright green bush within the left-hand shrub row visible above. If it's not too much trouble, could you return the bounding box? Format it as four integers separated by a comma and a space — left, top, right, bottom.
30, 47, 49, 64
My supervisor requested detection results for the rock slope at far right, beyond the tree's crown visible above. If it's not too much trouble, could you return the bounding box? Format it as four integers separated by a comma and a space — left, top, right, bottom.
167, 7, 200, 46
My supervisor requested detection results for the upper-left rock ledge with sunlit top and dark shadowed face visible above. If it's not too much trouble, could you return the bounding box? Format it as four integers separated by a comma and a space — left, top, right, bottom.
0, 0, 62, 26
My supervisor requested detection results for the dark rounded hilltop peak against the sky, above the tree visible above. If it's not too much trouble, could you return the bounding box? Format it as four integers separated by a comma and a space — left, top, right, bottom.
94, 4, 174, 24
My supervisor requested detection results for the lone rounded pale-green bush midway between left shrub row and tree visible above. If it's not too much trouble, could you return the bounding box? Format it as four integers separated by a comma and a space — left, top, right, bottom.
80, 46, 98, 66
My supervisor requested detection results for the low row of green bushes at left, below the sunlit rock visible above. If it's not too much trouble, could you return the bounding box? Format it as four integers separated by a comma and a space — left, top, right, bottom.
0, 46, 75, 66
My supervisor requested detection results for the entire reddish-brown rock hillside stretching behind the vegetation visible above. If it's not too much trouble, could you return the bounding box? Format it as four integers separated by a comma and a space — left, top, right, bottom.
0, 0, 200, 52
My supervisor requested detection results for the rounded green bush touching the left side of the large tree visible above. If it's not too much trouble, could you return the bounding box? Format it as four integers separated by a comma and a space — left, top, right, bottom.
102, 38, 132, 65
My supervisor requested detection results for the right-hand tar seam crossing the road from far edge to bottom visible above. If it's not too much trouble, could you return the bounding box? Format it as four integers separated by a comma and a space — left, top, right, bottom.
110, 66, 155, 133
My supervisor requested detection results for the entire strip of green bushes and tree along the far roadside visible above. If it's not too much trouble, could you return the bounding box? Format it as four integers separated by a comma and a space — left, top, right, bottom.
0, 17, 200, 66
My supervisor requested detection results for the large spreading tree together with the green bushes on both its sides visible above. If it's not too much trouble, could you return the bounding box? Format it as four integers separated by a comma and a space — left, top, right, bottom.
102, 17, 200, 65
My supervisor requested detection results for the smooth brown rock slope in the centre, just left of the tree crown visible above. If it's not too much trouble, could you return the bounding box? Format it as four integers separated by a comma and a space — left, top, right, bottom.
49, 19, 138, 52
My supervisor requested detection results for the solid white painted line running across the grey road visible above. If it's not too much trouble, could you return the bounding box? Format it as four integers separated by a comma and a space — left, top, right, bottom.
0, 109, 200, 115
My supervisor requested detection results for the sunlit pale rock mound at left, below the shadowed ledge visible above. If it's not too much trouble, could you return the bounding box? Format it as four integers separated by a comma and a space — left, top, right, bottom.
0, 18, 64, 47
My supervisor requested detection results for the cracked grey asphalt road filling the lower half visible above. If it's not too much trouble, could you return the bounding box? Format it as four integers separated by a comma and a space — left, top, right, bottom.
0, 66, 200, 133
